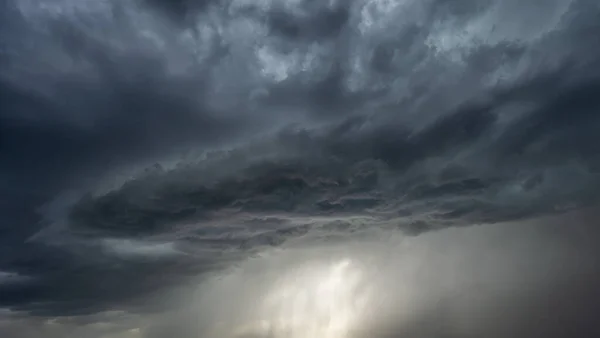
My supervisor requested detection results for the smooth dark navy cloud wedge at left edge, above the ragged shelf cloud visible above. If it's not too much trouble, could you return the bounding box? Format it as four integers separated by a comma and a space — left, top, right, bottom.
0, 26, 240, 190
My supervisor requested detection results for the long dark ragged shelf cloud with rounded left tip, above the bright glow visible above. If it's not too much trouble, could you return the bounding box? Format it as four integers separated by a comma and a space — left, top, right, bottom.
62, 66, 600, 240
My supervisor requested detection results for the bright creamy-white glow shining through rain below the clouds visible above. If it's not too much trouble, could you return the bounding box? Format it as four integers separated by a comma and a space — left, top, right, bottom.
238, 260, 368, 338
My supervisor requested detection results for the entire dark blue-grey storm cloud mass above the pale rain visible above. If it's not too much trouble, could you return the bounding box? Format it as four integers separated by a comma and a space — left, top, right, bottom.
0, 0, 600, 332
